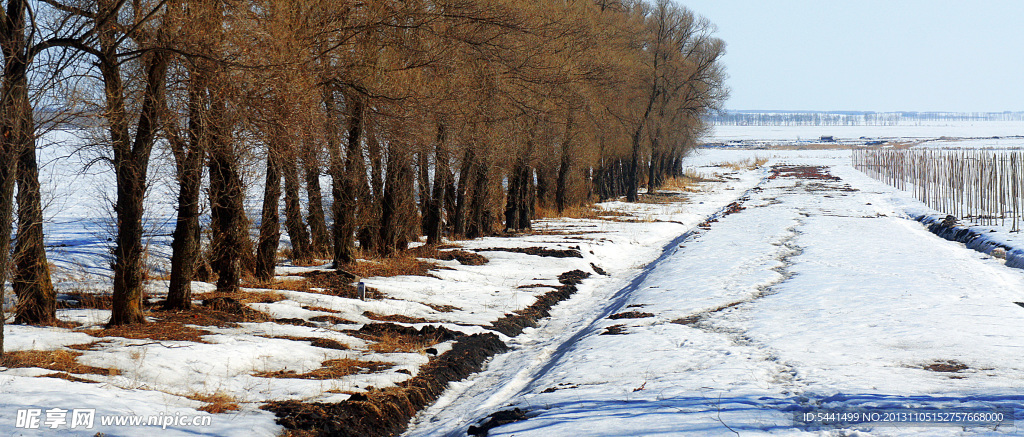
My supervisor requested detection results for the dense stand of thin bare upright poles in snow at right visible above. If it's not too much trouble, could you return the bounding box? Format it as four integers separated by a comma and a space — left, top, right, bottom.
852, 148, 1024, 231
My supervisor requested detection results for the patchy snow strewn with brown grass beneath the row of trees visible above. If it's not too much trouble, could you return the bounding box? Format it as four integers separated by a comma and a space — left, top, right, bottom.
0, 145, 764, 436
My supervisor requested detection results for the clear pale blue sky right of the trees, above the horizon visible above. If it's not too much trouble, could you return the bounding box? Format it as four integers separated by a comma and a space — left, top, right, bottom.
676, 0, 1024, 112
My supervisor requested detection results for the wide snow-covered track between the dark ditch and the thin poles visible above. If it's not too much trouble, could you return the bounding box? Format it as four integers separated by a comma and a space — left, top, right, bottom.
408, 150, 1024, 436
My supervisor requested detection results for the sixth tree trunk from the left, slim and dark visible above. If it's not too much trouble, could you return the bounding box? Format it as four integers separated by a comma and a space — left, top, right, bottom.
255, 143, 282, 282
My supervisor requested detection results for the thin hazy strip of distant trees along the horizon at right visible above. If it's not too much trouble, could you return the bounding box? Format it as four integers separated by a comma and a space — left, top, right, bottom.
710, 111, 1024, 126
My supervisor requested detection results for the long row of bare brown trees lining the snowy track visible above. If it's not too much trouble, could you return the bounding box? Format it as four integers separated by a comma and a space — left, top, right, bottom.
0, 0, 727, 356
